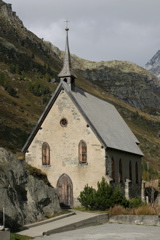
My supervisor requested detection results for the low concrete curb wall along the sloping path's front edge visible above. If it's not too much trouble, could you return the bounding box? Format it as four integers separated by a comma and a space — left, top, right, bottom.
43, 213, 109, 235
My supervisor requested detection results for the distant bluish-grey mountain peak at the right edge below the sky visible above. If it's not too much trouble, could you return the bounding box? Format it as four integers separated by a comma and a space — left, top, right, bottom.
145, 50, 160, 78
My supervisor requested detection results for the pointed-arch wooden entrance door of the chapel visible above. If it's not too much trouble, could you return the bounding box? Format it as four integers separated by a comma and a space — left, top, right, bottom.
57, 174, 73, 208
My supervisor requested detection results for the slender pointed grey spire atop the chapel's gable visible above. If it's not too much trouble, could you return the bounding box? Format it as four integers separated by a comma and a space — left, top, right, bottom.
58, 27, 76, 89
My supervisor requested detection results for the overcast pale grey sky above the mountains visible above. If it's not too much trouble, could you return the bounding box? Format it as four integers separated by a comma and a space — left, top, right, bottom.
3, 0, 160, 66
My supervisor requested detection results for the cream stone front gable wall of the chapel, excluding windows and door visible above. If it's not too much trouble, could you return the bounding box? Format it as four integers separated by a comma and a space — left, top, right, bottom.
26, 90, 105, 204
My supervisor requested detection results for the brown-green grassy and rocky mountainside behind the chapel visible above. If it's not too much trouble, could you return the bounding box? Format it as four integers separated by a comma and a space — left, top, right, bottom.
0, 0, 160, 179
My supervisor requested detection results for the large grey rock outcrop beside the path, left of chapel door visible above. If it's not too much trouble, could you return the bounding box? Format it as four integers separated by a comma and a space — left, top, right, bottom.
0, 148, 61, 229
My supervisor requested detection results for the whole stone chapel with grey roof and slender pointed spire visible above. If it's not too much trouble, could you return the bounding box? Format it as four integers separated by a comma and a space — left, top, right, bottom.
22, 28, 143, 207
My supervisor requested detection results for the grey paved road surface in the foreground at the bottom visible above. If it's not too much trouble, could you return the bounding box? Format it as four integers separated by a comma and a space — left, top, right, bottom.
35, 223, 160, 240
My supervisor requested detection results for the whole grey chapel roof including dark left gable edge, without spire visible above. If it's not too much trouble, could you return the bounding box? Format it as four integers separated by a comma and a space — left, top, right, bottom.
22, 81, 143, 156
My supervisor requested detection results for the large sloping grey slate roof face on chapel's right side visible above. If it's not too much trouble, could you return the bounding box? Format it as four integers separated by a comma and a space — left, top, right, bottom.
72, 84, 143, 155
